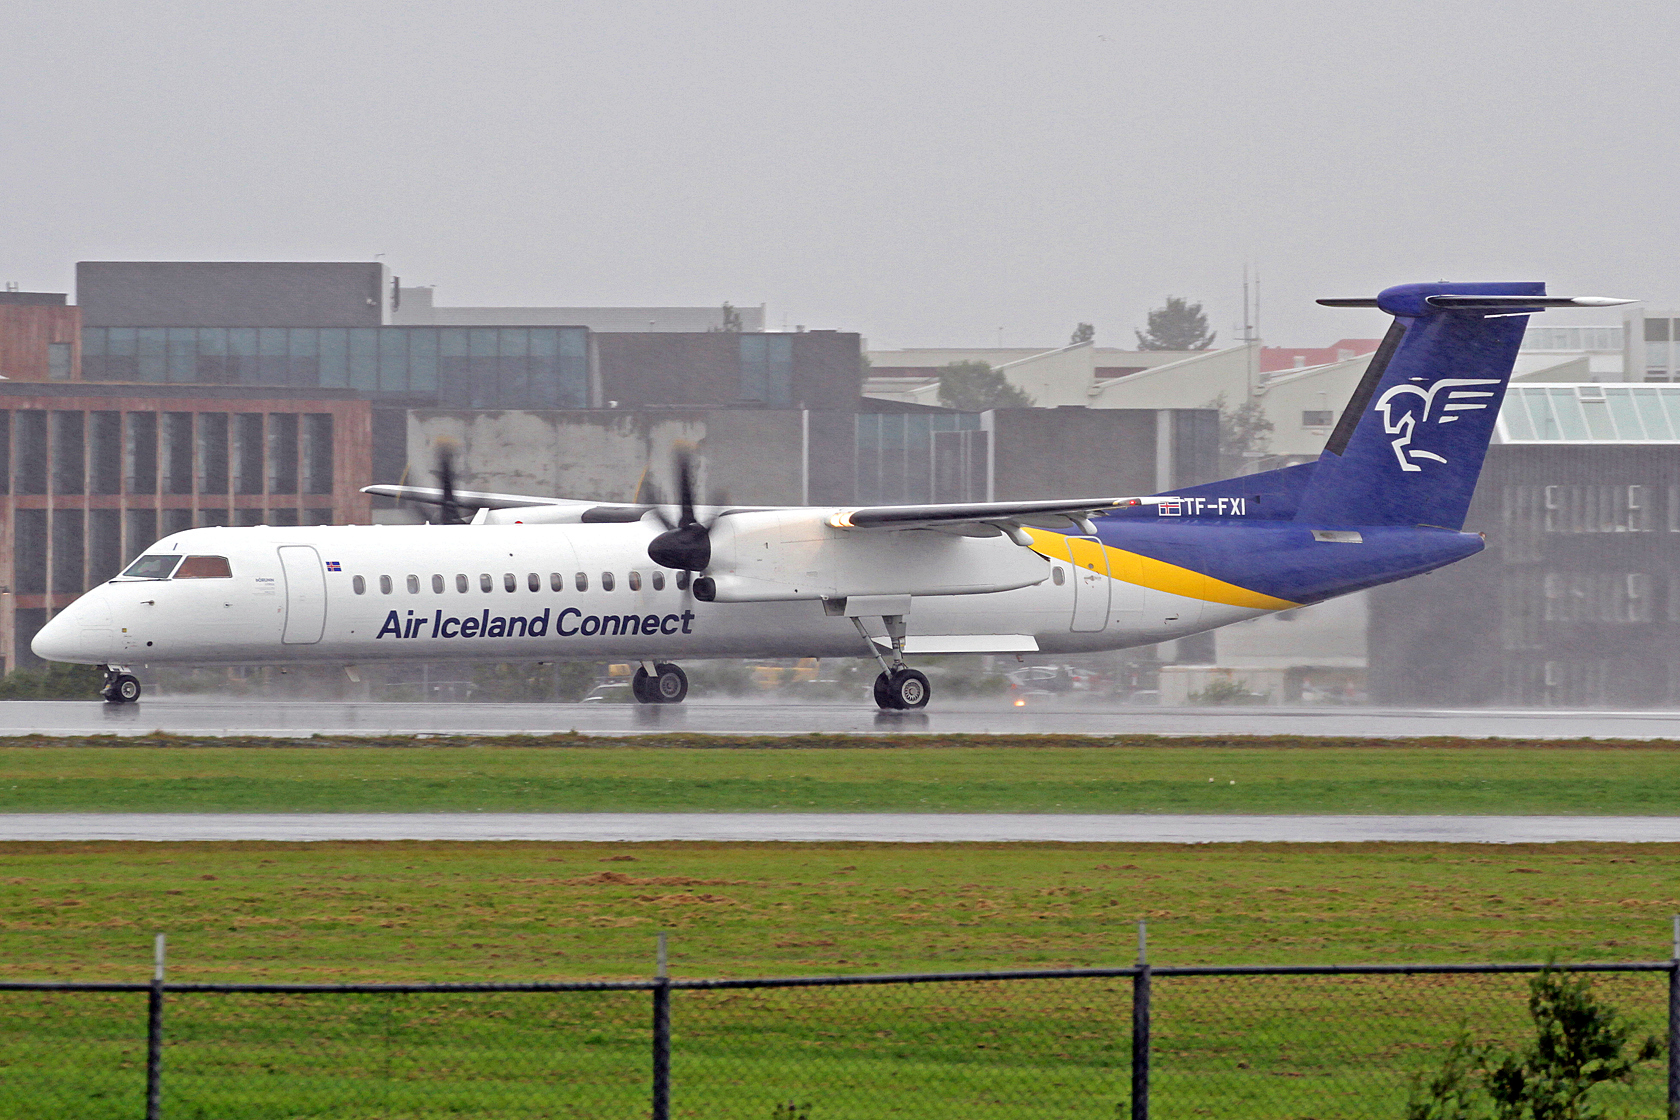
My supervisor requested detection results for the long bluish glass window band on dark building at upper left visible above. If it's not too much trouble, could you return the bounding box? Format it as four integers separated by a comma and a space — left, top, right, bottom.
82, 327, 591, 408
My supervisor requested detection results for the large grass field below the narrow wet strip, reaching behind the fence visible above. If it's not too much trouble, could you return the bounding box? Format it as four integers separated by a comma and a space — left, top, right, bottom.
0, 843, 1680, 1120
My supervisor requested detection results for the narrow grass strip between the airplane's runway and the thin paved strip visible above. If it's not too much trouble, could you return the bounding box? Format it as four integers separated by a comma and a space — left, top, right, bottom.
0, 735, 1680, 814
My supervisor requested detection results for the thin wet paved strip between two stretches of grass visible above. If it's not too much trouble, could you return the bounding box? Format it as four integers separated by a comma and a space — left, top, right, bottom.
0, 813, 1680, 845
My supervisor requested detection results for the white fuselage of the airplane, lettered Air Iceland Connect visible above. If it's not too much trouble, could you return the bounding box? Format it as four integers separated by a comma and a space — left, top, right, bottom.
35, 522, 1265, 665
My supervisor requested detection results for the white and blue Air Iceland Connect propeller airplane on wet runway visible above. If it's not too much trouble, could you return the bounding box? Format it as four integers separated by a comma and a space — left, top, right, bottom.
32, 282, 1631, 710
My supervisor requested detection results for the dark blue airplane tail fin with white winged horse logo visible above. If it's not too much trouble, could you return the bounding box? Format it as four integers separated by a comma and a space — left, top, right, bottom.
1295, 284, 1545, 529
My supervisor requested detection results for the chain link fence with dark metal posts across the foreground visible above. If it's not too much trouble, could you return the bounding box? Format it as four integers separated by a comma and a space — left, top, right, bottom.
0, 960, 1680, 1120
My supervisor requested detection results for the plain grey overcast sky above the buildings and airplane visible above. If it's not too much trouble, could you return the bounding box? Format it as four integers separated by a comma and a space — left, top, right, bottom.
0, 0, 1680, 346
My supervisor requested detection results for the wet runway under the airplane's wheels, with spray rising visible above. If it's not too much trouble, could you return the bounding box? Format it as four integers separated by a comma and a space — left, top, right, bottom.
0, 697, 1680, 739
